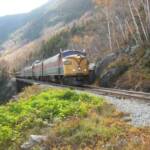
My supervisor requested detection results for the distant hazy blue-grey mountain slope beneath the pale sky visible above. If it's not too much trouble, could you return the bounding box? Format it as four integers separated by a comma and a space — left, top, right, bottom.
0, 0, 92, 50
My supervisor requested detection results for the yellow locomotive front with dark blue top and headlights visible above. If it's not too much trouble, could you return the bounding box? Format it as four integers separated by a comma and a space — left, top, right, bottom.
62, 50, 89, 84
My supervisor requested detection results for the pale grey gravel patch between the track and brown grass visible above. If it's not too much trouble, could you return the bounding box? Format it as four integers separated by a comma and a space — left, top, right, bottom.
104, 96, 150, 126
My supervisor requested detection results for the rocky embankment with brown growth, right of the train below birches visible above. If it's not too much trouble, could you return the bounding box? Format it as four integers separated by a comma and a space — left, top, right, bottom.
96, 47, 150, 92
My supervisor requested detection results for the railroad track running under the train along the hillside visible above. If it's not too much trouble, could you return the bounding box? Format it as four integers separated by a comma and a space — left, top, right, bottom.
17, 79, 150, 100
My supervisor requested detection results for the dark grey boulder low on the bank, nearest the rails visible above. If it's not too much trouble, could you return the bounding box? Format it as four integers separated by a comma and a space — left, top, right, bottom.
100, 66, 128, 87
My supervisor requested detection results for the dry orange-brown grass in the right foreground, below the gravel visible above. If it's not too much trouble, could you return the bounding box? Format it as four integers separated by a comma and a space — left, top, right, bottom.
45, 108, 150, 150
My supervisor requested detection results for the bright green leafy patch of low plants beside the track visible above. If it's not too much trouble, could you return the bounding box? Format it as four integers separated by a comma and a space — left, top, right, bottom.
0, 89, 104, 147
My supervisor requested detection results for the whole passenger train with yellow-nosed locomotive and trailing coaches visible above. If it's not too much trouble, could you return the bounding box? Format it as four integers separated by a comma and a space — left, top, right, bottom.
16, 50, 90, 84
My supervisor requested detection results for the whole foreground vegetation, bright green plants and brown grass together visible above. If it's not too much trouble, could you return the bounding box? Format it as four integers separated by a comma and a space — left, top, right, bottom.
0, 86, 150, 150
